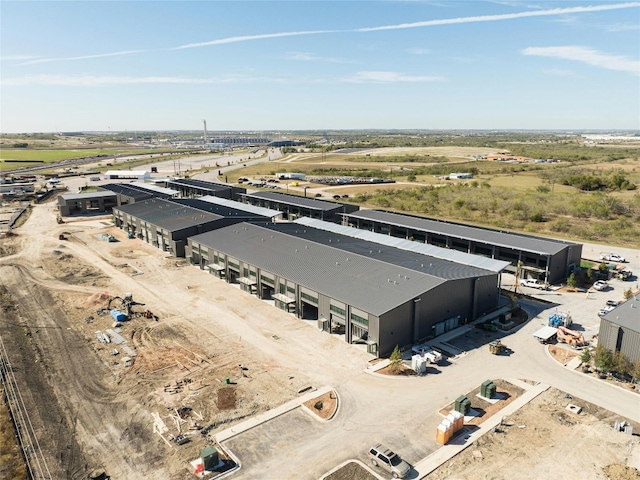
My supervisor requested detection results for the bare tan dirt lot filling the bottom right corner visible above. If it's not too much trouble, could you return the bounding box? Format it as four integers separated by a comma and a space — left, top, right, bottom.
426, 389, 640, 480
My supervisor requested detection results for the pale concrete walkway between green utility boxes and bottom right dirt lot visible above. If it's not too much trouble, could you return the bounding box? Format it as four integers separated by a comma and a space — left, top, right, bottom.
413, 380, 549, 478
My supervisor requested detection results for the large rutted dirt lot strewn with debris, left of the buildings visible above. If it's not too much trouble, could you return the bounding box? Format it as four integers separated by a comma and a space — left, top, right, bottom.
0, 201, 316, 479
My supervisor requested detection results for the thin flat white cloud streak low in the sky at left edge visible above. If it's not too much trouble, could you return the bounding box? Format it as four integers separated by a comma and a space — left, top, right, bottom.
2, 75, 256, 87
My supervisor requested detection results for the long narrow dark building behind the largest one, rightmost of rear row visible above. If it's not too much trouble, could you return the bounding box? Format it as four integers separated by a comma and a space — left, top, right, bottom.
342, 210, 582, 283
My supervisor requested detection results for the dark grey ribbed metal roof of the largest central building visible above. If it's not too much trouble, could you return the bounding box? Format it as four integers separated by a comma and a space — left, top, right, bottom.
190, 223, 492, 315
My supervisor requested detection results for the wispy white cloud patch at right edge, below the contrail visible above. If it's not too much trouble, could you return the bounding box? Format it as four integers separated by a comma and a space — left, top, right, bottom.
522, 46, 640, 75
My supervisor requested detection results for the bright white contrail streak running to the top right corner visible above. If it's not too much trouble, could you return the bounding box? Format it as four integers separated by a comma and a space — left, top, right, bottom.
353, 2, 640, 32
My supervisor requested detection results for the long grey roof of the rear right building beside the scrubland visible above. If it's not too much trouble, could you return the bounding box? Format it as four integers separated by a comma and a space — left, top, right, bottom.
344, 210, 579, 255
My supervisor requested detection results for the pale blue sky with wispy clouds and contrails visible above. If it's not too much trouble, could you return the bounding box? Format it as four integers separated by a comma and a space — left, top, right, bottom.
0, 0, 640, 133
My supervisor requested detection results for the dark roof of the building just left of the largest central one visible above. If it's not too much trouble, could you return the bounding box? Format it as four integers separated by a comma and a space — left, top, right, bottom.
113, 198, 223, 232
